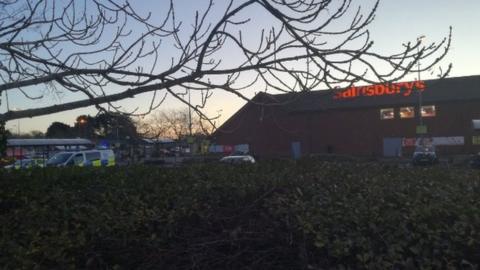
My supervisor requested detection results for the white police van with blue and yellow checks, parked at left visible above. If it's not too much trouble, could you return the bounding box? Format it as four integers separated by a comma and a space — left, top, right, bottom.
47, 149, 115, 167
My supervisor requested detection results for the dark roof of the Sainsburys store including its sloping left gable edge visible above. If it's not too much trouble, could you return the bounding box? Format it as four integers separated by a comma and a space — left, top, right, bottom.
212, 75, 480, 137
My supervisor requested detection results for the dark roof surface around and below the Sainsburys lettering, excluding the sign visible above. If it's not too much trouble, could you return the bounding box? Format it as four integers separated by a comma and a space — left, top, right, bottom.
268, 75, 480, 112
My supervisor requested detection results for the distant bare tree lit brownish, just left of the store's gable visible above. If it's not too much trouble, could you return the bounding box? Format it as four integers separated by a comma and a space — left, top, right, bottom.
137, 109, 214, 139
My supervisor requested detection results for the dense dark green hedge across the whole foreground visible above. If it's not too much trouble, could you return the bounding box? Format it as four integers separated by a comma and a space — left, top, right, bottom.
0, 160, 480, 269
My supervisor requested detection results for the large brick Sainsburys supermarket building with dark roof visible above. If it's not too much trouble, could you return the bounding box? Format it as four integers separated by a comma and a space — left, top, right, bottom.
213, 76, 480, 158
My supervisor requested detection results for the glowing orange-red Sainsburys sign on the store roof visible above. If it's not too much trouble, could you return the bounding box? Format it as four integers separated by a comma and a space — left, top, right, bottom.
333, 81, 425, 99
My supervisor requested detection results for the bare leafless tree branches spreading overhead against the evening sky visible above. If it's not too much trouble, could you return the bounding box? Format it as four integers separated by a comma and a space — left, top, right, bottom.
0, 0, 451, 122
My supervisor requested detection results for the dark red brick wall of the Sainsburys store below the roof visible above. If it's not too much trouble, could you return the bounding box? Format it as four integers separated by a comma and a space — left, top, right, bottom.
214, 77, 480, 158
